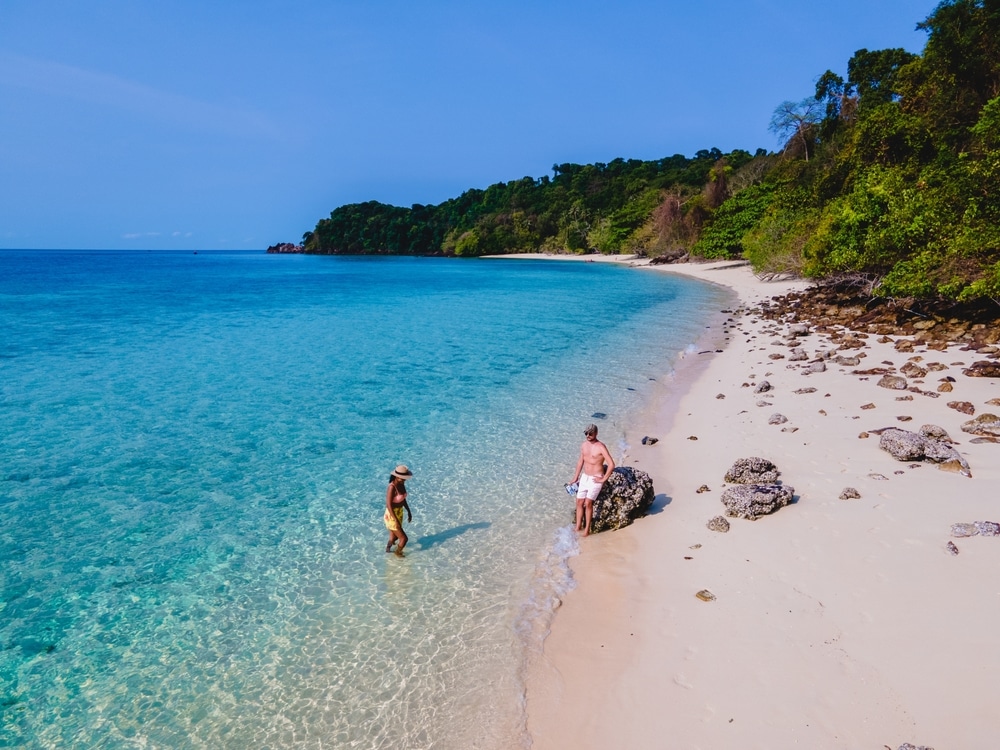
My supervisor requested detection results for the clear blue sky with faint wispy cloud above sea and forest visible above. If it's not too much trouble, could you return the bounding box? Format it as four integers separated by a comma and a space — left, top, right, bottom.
0, 0, 936, 249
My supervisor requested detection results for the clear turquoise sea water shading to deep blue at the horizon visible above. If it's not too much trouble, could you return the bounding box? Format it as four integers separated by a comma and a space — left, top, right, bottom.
0, 251, 728, 750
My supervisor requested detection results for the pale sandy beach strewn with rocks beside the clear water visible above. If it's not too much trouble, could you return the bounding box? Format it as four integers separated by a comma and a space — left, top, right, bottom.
517, 256, 1000, 750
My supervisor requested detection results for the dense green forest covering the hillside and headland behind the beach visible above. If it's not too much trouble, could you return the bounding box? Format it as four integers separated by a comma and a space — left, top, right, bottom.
303, 0, 1000, 300
